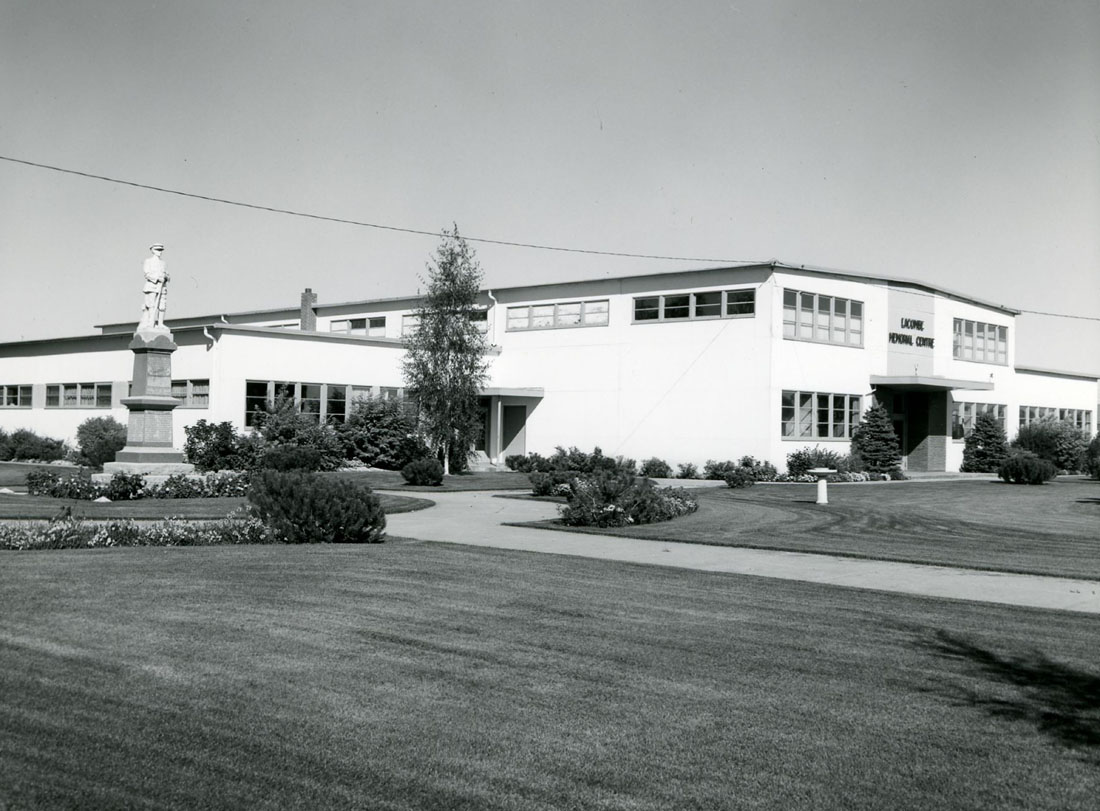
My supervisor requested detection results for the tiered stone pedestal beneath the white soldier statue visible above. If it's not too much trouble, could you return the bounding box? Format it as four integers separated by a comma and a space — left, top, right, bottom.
103, 327, 195, 475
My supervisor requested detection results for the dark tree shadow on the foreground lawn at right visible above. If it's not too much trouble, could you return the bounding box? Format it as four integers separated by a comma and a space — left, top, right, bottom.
920, 631, 1100, 766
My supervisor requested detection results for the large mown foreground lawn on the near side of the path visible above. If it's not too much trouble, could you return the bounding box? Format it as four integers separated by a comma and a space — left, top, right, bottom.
0, 544, 1100, 811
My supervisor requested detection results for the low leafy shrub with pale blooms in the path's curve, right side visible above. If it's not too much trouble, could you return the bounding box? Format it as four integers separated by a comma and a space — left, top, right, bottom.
561, 471, 699, 527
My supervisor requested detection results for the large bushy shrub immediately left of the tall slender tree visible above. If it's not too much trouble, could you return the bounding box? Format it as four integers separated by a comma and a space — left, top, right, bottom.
336, 397, 431, 470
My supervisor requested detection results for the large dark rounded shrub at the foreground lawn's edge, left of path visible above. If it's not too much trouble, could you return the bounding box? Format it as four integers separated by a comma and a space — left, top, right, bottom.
249, 470, 386, 544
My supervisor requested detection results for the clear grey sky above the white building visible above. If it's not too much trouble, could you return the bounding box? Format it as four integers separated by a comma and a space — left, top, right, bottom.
0, 0, 1100, 373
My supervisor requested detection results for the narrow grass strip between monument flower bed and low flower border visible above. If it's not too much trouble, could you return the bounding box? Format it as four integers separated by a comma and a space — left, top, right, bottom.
0, 493, 432, 520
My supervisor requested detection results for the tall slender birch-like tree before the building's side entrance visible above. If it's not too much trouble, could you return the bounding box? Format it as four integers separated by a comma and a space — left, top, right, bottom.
403, 226, 488, 474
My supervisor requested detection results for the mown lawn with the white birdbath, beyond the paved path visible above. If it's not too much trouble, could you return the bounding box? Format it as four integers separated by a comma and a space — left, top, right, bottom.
514, 476, 1100, 580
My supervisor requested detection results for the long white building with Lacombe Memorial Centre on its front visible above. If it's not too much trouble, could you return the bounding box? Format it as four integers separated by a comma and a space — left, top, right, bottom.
0, 263, 1098, 470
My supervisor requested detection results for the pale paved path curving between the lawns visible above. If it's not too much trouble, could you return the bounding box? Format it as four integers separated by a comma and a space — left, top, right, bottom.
387, 492, 1100, 614
